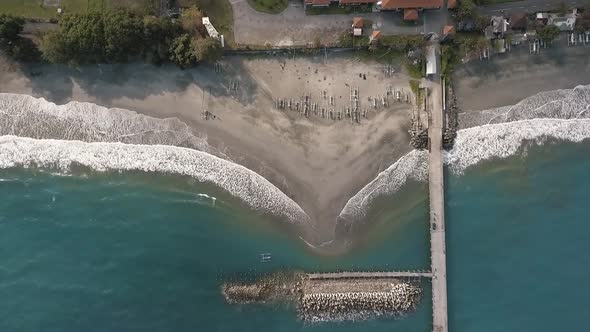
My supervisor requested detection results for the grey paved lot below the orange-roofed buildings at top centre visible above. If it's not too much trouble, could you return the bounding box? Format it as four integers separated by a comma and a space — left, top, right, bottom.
230, 0, 423, 46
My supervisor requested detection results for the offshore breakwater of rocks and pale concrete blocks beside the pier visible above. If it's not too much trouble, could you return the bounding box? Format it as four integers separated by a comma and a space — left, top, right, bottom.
221, 273, 422, 321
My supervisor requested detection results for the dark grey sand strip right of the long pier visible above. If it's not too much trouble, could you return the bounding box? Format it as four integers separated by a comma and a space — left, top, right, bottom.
454, 45, 590, 112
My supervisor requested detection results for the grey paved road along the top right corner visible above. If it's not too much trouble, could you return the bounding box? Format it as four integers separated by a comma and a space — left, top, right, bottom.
478, 0, 586, 16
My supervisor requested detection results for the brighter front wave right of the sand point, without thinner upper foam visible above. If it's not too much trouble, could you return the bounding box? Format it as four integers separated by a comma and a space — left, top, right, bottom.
338, 119, 590, 229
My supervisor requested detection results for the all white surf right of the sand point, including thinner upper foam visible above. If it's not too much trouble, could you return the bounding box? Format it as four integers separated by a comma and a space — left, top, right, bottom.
338, 85, 590, 229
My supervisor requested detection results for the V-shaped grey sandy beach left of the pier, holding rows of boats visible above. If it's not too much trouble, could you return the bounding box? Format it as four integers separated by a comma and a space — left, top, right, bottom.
0, 55, 413, 242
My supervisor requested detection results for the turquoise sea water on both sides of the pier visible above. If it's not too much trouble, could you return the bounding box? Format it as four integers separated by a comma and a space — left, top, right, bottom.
0, 144, 590, 332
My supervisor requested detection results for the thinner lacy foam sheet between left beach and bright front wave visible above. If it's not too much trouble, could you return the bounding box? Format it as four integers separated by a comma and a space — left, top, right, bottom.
0, 93, 222, 159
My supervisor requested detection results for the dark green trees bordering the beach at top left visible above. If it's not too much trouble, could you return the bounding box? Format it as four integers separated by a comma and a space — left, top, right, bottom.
0, 7, 222, 68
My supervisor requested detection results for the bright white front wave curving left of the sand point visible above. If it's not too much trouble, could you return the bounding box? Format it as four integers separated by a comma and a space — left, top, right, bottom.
0, 135, 310, 225
